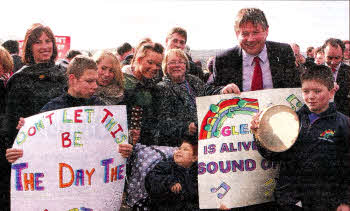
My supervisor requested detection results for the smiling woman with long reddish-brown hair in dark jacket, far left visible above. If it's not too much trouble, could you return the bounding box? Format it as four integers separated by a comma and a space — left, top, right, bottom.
1, 24, 66, 210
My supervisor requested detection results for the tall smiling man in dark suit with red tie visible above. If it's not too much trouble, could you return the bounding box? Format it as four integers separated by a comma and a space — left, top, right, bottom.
211, 8, 300, 94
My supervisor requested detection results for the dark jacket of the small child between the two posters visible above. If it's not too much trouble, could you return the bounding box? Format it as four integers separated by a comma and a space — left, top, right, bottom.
145, 158, 199, 211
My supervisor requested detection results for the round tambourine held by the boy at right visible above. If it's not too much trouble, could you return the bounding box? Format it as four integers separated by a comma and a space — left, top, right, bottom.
256, 105, 300, 152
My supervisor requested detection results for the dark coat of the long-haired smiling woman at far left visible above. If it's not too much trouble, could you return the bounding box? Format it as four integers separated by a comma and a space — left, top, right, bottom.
6, 63, 67, 139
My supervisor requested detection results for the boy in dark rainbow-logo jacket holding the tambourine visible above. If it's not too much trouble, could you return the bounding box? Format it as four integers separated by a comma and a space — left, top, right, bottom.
251, 65, 350, 211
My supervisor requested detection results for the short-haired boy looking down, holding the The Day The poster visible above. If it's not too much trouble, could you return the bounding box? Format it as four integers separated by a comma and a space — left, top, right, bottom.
6, 55, 132, 163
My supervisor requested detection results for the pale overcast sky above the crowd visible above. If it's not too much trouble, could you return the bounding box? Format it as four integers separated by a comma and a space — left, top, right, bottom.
0, 0, 349, 51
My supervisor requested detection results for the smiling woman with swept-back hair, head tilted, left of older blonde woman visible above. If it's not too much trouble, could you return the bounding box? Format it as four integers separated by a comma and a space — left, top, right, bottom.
124, 41, 164, 145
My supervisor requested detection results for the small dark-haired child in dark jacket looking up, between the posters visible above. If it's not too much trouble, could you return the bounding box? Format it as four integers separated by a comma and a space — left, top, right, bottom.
145, 136, 199, 211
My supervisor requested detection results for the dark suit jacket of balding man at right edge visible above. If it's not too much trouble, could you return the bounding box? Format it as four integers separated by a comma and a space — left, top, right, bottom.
334, 63, 350, 116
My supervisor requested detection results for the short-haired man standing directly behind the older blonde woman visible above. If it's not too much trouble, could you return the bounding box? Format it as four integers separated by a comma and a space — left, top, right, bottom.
165, 27, 204, 80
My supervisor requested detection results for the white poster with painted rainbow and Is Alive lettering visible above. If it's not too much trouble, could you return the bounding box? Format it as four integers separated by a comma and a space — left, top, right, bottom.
196, 88, 303, 209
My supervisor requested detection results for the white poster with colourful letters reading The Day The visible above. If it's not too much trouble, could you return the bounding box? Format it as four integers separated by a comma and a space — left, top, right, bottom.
11, 106, 128, 211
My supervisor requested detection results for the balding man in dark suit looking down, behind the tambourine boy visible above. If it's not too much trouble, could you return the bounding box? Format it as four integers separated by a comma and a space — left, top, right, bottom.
322, 38, 350, 116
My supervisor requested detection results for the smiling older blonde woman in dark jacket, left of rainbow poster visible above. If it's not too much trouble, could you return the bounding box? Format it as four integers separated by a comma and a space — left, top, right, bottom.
157, 49, 216, 146
